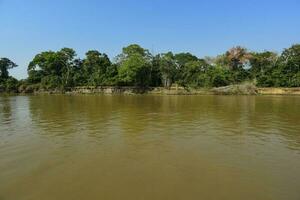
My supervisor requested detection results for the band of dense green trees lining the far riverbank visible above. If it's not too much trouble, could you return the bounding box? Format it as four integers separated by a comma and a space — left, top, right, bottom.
0, 44, 300, 91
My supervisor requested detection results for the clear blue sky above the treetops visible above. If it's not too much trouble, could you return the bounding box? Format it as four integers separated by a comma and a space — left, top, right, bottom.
0, 0, 300, 78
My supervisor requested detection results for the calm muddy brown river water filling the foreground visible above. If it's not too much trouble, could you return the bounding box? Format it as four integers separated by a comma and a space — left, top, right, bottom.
0, 95, 300, 200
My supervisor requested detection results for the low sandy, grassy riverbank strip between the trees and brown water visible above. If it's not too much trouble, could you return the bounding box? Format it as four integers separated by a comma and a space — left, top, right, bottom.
0, 83, 300, 95
